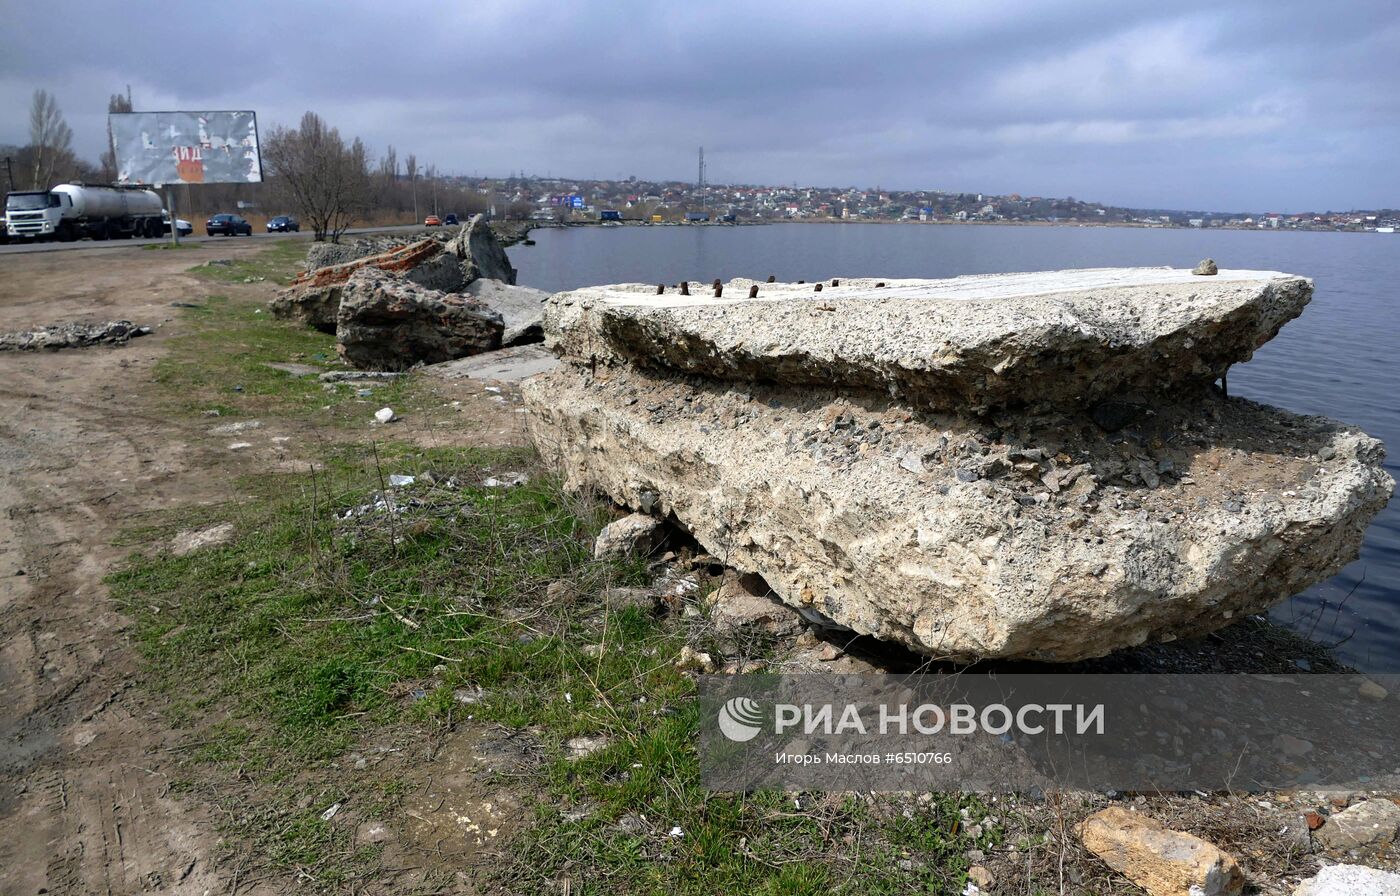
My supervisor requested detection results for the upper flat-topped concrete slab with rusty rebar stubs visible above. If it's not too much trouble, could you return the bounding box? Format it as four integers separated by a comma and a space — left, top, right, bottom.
545, 267, 1312, 412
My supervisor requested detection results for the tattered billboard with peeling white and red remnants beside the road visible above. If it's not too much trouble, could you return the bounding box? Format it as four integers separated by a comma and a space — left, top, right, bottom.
108, 112, 262, 185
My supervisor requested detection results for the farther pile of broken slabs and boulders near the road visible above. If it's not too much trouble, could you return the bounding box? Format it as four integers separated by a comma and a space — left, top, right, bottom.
270, 216, 547, 370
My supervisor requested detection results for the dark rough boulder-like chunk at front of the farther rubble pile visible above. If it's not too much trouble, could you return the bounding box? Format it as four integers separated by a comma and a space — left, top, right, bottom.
336, 267, 504, 371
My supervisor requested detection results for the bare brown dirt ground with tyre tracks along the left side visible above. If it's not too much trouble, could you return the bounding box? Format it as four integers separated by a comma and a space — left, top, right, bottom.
0, 244, 522, 896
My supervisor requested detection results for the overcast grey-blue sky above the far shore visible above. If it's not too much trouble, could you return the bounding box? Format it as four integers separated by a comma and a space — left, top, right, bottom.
0, 0, 1400, 211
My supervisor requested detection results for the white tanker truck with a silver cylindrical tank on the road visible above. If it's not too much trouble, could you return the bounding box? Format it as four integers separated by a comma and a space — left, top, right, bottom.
4, 183, 165, 242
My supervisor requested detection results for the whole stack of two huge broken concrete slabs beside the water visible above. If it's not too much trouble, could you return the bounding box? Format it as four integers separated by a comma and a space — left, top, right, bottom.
525, 269, 1393, 662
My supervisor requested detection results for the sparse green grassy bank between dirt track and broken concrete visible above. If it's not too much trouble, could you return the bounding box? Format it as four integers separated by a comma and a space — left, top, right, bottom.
109, 248, 997, 895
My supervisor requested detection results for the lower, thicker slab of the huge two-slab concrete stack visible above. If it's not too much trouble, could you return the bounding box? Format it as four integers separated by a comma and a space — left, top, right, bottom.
522, 365, 1393, 662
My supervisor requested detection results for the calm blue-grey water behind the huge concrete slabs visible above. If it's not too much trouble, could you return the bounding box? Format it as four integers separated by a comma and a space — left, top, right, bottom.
511, 224, 1400, 672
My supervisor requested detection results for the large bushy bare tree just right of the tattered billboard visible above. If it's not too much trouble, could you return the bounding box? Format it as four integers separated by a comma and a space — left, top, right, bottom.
262, 112, 372, 242
